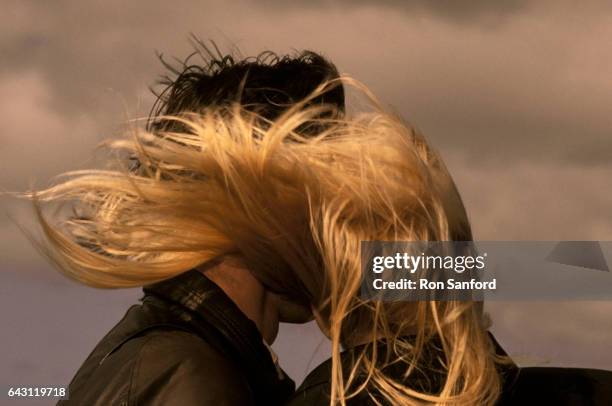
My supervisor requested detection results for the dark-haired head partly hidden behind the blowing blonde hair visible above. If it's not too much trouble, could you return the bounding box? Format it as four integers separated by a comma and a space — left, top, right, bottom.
142, 43, 345, 323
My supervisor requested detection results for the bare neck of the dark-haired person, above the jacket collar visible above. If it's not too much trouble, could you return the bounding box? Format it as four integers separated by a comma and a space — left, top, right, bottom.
196, 257, 278, 344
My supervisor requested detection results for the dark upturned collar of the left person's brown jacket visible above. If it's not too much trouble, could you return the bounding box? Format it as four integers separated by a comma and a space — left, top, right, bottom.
143, 269, 295, 403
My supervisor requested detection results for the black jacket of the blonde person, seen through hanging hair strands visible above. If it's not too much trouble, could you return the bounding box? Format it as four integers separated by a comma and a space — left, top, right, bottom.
287, 336, 612, 406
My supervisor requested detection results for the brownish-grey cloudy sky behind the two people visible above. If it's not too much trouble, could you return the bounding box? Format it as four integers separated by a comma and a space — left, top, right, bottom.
0, 0, 612, 390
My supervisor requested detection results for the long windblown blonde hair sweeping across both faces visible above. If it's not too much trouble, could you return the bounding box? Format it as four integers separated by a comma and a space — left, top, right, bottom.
21, 77, 500, 405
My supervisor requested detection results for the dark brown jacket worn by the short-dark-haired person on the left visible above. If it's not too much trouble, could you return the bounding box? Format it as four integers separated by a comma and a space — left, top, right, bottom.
59, 270, 294, 406
